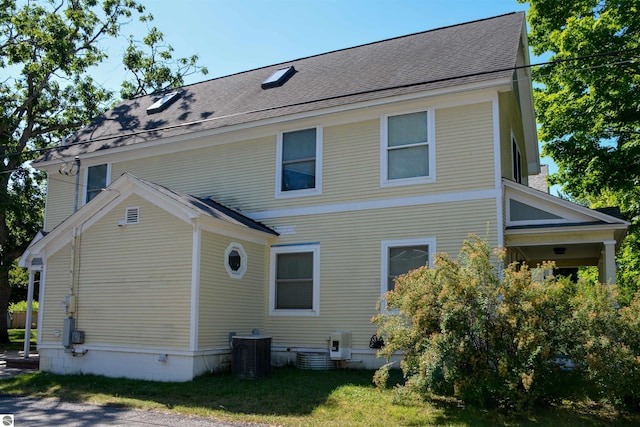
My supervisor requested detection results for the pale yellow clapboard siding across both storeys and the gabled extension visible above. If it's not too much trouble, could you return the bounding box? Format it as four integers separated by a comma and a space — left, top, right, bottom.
40, 95, 504, 356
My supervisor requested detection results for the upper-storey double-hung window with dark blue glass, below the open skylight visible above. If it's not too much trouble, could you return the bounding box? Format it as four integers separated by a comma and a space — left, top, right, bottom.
276, 128, 322, 197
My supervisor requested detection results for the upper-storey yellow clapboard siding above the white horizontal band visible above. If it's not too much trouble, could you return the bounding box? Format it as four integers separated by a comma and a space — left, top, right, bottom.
47, 101, 495, 229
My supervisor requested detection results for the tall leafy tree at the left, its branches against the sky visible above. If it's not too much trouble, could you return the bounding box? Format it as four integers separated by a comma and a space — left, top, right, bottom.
0, 0, 206, 343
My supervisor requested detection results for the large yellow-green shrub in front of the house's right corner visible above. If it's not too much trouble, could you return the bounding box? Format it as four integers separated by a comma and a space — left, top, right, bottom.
373, 236, 640, 407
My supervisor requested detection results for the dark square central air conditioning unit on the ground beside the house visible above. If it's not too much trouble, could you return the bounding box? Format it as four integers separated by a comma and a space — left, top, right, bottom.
231, 335, 271, 379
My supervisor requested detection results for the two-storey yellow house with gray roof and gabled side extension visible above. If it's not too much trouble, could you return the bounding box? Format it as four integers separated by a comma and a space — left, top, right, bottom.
21, 13, 628, 381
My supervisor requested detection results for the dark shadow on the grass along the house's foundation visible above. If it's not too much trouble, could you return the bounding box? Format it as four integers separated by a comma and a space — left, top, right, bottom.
0, 367, 374, 416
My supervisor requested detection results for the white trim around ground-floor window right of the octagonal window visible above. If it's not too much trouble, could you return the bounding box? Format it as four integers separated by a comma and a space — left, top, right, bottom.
269, 243, 320, 316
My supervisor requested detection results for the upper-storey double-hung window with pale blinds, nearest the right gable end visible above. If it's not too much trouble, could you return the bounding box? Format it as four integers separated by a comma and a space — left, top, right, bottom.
380, 111, 435, 186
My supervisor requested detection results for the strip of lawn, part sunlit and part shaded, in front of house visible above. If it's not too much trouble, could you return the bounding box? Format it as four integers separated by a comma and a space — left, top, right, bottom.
0, 367, 640, 427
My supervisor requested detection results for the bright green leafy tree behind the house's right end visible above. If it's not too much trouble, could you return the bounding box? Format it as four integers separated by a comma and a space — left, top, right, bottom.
518, 0, 640, 303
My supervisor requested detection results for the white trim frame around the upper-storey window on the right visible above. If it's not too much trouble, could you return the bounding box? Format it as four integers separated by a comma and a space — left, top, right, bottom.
380, 108, 436, 187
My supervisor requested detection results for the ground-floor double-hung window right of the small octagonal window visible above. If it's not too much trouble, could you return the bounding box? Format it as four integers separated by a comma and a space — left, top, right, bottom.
269, 244, 320, 316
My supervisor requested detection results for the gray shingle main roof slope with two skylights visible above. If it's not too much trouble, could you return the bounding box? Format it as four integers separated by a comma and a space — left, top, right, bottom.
39, 12, 524, 161
